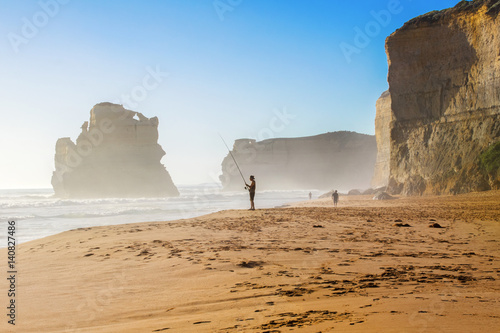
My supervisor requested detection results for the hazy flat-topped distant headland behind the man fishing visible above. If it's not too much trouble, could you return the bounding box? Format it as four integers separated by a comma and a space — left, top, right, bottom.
220, 132, 377, 190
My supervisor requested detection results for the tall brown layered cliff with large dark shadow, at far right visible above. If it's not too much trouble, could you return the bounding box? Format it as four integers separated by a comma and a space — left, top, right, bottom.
386, 0, 500, 195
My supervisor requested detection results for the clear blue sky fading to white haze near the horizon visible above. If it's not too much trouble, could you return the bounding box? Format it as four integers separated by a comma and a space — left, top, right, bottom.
0, 0, 458, 188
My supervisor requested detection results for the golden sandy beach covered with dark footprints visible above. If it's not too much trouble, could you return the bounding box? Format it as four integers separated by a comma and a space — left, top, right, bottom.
0, 191, 500, 332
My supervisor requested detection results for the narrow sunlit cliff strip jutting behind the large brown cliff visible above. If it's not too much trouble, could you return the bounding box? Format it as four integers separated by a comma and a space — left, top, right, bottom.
371, 91, 394, 188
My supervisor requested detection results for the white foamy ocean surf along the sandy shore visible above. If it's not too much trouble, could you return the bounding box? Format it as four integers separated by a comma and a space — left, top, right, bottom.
0, 184, 322, 248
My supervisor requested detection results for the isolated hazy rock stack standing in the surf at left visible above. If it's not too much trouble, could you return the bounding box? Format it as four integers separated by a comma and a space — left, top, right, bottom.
52, 103, 179, 198
